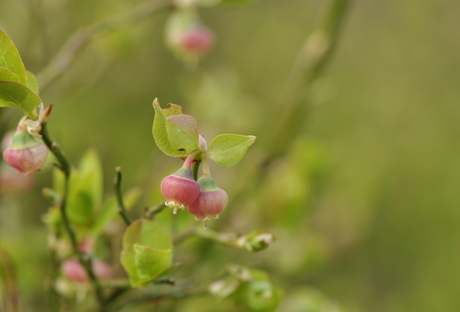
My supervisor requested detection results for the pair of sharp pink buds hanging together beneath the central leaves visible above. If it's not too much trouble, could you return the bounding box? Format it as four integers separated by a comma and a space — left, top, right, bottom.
161, 163, 228, 221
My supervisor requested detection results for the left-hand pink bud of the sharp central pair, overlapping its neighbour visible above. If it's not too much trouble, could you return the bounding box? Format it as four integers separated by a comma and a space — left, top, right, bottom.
161, 167, 200, 214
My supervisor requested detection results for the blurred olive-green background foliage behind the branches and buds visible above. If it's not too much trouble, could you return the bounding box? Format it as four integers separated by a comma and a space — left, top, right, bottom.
0, 0, 460, 312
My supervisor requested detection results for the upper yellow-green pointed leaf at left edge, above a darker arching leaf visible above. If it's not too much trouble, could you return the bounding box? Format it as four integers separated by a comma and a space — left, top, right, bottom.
0, 28, 27, 85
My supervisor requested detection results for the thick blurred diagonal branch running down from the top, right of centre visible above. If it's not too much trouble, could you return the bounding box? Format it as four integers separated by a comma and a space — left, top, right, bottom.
229, 0, 352, 212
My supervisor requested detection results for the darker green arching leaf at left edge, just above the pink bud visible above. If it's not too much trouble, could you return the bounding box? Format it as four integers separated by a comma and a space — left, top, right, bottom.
0, 80, 42, 119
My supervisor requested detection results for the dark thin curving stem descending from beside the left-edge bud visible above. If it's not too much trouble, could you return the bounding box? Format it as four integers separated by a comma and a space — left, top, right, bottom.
40, 117, 103, 309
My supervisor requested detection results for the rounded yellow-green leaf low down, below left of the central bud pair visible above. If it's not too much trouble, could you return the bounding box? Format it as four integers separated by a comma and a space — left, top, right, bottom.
121, 219, 177, 287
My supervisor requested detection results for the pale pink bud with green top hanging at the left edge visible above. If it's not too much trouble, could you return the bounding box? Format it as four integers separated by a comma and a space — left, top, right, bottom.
3, 124, 48, 175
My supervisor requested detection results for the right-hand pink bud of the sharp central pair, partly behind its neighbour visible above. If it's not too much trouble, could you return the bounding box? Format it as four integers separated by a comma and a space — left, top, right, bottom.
188, 176, 228, 221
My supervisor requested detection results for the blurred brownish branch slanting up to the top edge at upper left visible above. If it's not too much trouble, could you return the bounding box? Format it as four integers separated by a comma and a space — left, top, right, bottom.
37, 0, 170, 90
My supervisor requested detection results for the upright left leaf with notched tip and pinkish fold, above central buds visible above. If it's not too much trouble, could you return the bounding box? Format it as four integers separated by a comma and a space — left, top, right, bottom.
152, 99, 199, 157
